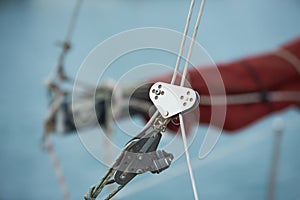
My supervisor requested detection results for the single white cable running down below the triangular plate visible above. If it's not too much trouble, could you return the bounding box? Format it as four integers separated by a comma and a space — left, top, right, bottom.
179, 113, 198, 200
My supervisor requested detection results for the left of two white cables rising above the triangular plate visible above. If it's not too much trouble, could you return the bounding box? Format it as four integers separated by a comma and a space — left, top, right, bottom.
171, 0, 195, 84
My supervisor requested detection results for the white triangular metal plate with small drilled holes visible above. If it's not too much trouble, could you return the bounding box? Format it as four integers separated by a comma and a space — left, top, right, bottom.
149, 82, 200, 118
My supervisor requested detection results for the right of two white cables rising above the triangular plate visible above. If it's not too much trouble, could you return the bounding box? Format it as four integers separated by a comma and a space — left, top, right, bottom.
180, 0, 205, 86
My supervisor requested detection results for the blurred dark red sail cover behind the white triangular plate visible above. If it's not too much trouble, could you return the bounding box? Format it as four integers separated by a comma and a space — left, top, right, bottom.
150, 38, 300, 131
